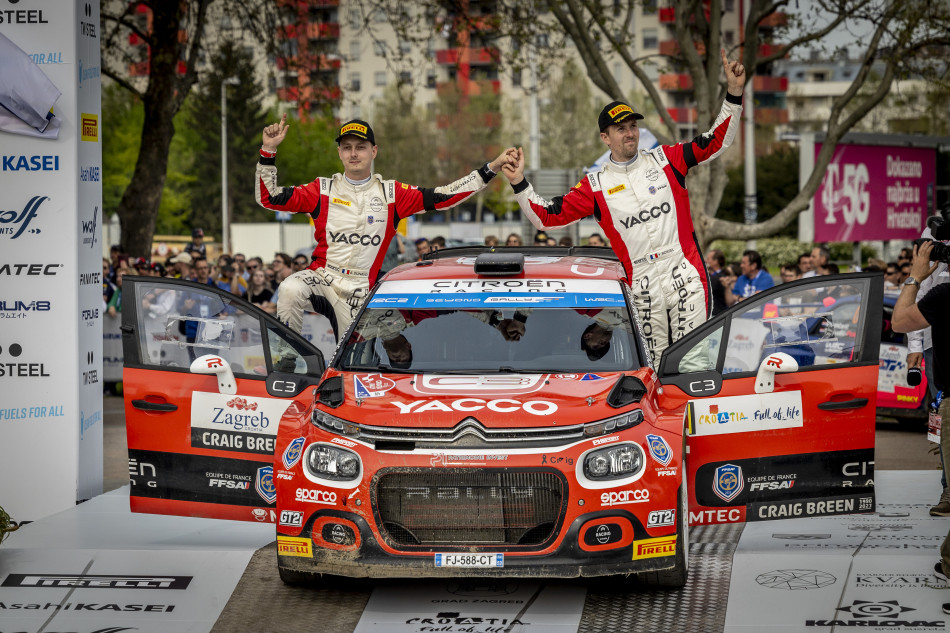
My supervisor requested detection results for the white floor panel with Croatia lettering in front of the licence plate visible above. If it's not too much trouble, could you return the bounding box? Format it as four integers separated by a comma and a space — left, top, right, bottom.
354, 577, 585, 633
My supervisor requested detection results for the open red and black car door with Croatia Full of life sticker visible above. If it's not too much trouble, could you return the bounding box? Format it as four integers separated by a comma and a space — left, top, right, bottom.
658, 273, 883, 524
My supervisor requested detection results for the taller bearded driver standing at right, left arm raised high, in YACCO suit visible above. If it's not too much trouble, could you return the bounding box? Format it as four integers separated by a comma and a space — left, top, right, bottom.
503, 51, 745, 362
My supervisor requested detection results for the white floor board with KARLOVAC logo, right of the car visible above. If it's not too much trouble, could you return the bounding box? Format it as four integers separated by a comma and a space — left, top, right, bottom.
725, 471, 950, 633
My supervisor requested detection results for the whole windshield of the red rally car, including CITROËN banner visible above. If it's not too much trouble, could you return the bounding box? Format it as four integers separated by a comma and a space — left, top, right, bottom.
337, 279, 641, 373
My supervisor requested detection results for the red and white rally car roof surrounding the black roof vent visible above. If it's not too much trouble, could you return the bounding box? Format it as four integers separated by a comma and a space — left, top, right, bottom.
384, 246, 625, 281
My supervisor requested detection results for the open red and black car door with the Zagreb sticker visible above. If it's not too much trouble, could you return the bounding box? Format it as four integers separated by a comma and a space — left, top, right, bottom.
122, 276, 324, 522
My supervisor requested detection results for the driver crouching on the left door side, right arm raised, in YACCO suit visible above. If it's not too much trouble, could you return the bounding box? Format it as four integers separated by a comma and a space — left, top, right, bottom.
254, 114, 514, 339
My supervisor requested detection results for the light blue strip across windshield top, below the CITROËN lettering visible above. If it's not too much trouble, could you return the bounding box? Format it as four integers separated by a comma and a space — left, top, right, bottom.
369, 292, 625, 308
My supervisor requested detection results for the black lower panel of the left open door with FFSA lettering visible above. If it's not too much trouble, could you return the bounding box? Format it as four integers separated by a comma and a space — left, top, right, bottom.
129, 449, 276, 521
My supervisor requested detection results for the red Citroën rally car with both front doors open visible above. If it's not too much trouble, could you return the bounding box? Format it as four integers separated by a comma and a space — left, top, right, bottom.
122, 248, 882, 586
